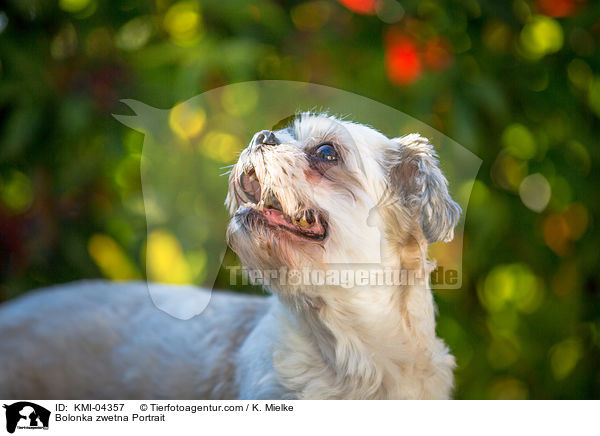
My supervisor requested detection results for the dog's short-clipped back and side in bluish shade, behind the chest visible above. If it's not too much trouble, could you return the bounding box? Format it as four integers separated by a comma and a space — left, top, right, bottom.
0, 280, 269, 399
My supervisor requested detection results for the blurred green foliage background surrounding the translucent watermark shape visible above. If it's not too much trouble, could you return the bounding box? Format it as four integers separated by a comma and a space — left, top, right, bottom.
0, 0, 600, 398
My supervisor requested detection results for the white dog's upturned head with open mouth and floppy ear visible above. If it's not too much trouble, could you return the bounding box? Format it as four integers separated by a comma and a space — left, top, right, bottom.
227, 113, 460, 286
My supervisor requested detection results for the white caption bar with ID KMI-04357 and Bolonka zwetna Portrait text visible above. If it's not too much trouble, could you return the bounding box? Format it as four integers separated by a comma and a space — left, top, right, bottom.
0, 400, 600, 436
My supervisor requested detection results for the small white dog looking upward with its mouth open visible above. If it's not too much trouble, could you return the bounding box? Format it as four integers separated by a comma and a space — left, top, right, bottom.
0, 113, 460, 399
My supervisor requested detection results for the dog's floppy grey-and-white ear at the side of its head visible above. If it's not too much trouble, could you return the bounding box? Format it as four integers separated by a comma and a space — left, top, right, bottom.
386, 134, 461, 243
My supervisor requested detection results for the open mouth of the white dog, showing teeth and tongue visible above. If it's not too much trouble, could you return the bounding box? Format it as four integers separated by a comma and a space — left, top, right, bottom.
236, 168, 327, 241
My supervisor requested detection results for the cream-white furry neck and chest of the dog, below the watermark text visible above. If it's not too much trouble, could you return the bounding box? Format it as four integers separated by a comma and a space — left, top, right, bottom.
274, 238, 454, 398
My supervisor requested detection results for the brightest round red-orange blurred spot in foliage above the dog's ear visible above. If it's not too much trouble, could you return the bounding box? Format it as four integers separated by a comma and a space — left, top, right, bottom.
385, 35, 421, 86
